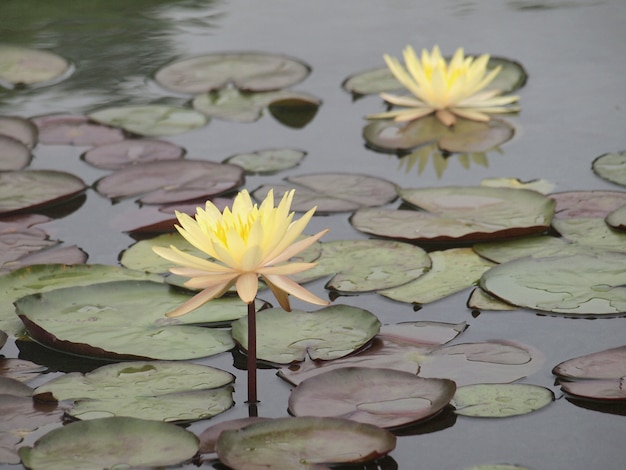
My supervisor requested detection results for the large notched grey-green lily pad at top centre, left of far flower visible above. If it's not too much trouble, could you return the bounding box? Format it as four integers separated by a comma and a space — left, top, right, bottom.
154, 52, 311, 94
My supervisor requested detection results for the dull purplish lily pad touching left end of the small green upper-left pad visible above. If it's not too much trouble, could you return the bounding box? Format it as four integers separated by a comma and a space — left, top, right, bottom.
32, 114, 124, 146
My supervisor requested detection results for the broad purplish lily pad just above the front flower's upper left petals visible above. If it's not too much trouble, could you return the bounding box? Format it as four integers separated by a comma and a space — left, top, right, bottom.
96, 160, 244, 204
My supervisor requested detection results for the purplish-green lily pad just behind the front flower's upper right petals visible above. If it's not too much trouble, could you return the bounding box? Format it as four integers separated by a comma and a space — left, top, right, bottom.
252, 173, 398, 214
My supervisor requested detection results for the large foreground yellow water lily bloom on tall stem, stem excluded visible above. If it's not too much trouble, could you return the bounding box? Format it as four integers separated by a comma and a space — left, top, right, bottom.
153, 190, 328, 317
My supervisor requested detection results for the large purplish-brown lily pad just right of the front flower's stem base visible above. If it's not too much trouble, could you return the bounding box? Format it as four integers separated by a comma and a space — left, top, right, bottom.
289, 367, 456, 428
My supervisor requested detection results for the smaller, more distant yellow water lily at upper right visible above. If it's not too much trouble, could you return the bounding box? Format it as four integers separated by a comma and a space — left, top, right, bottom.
367, 46, 519, 126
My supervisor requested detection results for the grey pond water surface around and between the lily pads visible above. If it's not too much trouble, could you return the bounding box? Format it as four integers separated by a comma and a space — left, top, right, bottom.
0, 0, 626, 470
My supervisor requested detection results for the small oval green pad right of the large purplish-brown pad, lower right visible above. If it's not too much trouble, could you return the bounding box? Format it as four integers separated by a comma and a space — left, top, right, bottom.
452, 384, 554, 418
